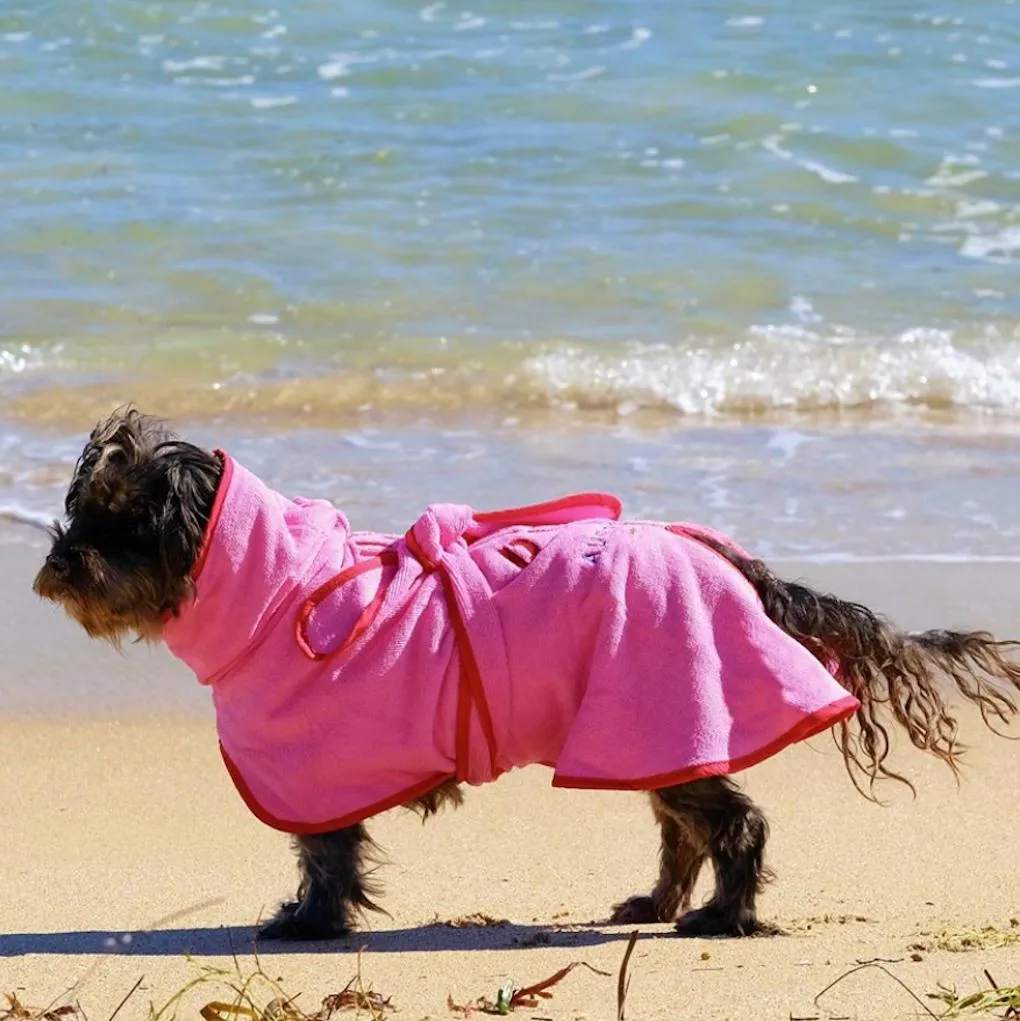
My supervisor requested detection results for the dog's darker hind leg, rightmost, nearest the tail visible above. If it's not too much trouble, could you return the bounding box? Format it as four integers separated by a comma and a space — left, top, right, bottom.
655, 777, 771, 936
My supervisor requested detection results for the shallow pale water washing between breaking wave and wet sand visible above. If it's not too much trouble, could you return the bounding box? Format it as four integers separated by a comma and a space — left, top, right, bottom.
0, 415, 1020, 566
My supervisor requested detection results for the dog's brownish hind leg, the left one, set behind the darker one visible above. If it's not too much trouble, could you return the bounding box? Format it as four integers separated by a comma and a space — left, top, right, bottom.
610, 791, 708, 925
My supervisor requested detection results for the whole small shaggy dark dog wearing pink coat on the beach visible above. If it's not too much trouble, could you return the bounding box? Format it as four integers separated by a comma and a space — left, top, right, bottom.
35, 409, 1020, 939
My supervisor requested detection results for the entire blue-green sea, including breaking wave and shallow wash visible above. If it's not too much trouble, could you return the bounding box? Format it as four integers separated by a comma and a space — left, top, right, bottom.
0, 0, 1020, 555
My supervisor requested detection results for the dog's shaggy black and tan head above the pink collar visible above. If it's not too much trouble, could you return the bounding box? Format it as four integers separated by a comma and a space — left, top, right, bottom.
33, 408, 223, 643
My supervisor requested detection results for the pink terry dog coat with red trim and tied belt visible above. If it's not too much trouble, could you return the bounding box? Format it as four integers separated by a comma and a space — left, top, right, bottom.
164, 455, 858, 833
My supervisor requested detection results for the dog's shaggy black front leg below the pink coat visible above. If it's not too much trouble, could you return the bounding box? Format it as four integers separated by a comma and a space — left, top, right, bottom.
258, 824, 382, 940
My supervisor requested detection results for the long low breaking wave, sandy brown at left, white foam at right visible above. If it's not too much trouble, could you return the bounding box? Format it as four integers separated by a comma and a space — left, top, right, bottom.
5, 326, 1020, 424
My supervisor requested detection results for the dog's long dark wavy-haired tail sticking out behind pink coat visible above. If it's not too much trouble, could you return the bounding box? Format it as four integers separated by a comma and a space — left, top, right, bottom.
698, 536, 1020, 800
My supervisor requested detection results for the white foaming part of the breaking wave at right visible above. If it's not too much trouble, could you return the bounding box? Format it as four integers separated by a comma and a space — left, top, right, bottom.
527, 327, 1020, 417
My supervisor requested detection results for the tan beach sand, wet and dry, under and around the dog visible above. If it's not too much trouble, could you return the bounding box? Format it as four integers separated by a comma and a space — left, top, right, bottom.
0, 530, 1020, 1021
